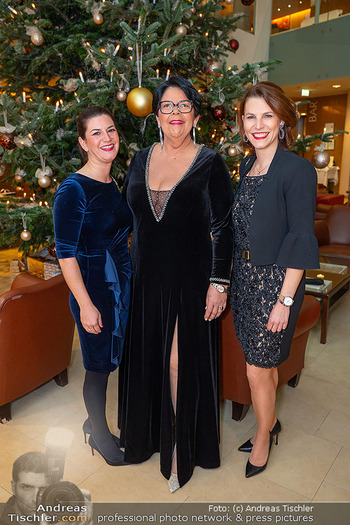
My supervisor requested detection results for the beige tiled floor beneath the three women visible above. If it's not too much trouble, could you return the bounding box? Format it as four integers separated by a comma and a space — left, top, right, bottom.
0, 250, 350, 502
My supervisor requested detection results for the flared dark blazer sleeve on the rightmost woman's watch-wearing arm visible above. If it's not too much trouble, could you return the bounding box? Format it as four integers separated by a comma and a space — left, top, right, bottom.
276, 161, 319, 270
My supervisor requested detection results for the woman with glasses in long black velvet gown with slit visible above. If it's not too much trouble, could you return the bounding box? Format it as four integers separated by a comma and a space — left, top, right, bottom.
119, 77, 233, 492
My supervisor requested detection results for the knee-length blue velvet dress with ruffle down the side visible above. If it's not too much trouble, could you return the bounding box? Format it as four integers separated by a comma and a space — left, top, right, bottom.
53, 173, 132, 373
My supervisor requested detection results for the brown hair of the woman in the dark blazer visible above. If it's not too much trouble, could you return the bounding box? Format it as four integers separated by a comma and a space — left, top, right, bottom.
238, 82, 298, 153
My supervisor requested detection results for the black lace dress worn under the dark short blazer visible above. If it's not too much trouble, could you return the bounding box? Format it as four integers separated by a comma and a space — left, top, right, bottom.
231, 175, 286, 368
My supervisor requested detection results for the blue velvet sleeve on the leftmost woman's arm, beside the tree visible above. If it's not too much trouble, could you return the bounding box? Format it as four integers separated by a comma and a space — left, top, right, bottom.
53, 179, 86, 259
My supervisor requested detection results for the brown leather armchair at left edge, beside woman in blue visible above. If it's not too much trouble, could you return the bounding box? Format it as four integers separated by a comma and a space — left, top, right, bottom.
0, 273, 74, 421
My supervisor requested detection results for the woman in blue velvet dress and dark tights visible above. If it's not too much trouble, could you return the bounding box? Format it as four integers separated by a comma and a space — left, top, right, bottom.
54, 106, 131, 465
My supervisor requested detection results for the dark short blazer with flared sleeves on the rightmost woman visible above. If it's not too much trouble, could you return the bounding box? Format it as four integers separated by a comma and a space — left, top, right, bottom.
238, 146, 319, 269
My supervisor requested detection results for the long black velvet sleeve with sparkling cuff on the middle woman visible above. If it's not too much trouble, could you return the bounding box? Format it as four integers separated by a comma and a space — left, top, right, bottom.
209, 153, 233, 284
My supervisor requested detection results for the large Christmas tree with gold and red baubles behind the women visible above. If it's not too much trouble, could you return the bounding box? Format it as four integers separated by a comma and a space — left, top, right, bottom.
0, 0, 271, 252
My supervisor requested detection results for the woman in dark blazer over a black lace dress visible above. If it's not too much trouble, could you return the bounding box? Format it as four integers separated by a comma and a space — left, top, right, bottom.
231, 82, 318, 477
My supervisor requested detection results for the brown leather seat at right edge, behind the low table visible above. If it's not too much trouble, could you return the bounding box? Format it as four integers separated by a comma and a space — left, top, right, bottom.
314, 205, 350, 265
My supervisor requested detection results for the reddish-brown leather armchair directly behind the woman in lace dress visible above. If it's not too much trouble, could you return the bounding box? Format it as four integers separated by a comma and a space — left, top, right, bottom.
220, 295, 320, 421
